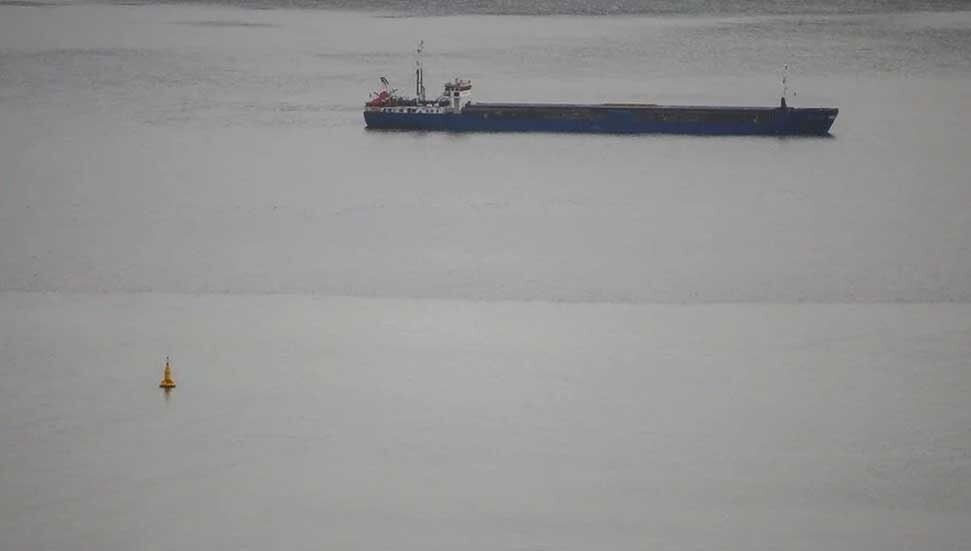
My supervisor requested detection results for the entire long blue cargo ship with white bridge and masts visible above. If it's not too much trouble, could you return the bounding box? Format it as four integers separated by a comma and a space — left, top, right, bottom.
364, 44, 839, 136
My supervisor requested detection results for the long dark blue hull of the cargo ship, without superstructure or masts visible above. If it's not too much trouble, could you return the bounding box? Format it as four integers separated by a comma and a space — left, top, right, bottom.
364, 104, 838, 136
